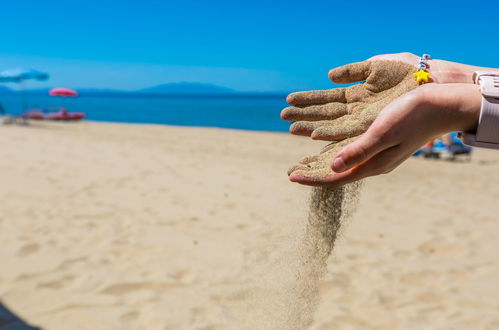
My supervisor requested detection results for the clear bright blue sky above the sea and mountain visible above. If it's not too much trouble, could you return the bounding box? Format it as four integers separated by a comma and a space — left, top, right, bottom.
0, 0, 499, 91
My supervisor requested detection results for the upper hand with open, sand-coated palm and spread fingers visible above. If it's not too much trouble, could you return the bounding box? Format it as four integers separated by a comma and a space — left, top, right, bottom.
281, 60, 419, 141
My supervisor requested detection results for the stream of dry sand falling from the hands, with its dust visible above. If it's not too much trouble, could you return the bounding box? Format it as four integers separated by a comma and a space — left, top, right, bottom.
223, 182, 361, 330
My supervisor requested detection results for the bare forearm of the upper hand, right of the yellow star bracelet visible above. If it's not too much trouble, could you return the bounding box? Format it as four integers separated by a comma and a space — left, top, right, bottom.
429, 60, 499, 84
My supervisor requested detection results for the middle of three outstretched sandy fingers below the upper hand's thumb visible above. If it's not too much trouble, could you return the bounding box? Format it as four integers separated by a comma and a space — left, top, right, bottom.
281, 102, 348, 121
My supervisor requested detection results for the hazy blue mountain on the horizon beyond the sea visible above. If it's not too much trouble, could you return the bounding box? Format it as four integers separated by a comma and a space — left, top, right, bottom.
136, 82, 236, 94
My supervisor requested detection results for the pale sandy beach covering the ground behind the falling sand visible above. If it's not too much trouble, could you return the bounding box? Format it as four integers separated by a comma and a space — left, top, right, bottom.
0, 122, 499, 330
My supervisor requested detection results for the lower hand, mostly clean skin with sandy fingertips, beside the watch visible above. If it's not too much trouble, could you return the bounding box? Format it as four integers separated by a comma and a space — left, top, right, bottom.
289, 84, 482, 188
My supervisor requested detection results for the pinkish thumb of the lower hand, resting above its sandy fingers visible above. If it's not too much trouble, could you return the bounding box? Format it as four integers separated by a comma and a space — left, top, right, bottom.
331, 131, 391, 173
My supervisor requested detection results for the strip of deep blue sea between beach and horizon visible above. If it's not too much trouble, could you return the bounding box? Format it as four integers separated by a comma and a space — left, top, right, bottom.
0, 93, 289, 132
